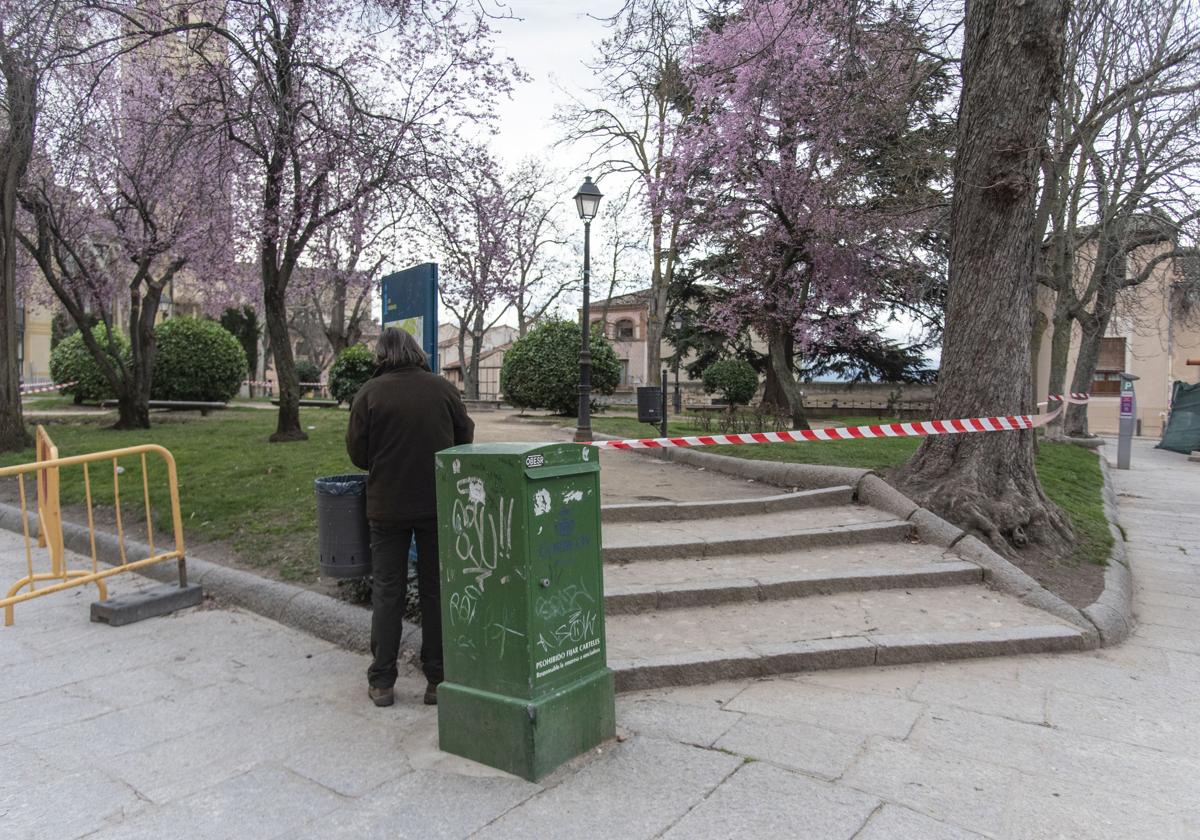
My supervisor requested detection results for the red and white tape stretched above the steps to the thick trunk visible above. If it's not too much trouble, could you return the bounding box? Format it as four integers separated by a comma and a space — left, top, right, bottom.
590, 394, 1088, 449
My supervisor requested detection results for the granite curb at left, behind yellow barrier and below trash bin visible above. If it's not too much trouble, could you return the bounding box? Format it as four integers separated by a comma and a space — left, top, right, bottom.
0, 504, 421, 659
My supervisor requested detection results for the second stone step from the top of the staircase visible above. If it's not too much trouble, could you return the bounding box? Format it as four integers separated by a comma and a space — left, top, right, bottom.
604, 505, 912, 563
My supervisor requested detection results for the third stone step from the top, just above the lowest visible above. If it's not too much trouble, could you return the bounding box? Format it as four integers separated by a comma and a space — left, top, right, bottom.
605, 542, 983, 616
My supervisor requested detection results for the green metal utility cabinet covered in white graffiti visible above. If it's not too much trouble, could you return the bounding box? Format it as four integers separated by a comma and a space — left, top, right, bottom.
437, 444, 616, 780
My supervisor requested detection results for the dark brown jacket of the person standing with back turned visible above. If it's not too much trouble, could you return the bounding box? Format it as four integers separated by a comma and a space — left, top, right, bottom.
346, 367, 475, 522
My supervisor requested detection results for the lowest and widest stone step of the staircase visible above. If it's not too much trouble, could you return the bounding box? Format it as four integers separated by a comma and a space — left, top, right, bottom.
606, 584, 1086, 691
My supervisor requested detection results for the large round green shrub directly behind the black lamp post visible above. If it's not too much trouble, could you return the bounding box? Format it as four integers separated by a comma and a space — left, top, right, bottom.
500, 320, 620, 416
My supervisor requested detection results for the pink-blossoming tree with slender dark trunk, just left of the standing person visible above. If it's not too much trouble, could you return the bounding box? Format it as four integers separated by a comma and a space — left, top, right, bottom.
182, 0, 514, 440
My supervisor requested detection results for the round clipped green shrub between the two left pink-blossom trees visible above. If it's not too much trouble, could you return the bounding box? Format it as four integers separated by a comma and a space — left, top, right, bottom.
150, 318, 246, 402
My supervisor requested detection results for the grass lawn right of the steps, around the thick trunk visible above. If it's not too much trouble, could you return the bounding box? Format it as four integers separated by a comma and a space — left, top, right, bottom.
592, 416, 1112, 565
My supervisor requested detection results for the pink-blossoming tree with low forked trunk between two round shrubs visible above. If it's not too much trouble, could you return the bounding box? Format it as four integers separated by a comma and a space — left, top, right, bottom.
17, 41, 230, 428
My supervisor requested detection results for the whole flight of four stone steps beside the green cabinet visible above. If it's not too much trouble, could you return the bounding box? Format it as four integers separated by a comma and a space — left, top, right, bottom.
602, 487, 1085, 691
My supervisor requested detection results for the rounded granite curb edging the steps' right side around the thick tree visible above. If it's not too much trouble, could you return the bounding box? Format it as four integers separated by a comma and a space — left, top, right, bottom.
595, 434, 1133, 648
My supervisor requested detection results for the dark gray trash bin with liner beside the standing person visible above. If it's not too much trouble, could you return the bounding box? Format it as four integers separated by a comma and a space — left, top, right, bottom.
312, 473, 371, 577
